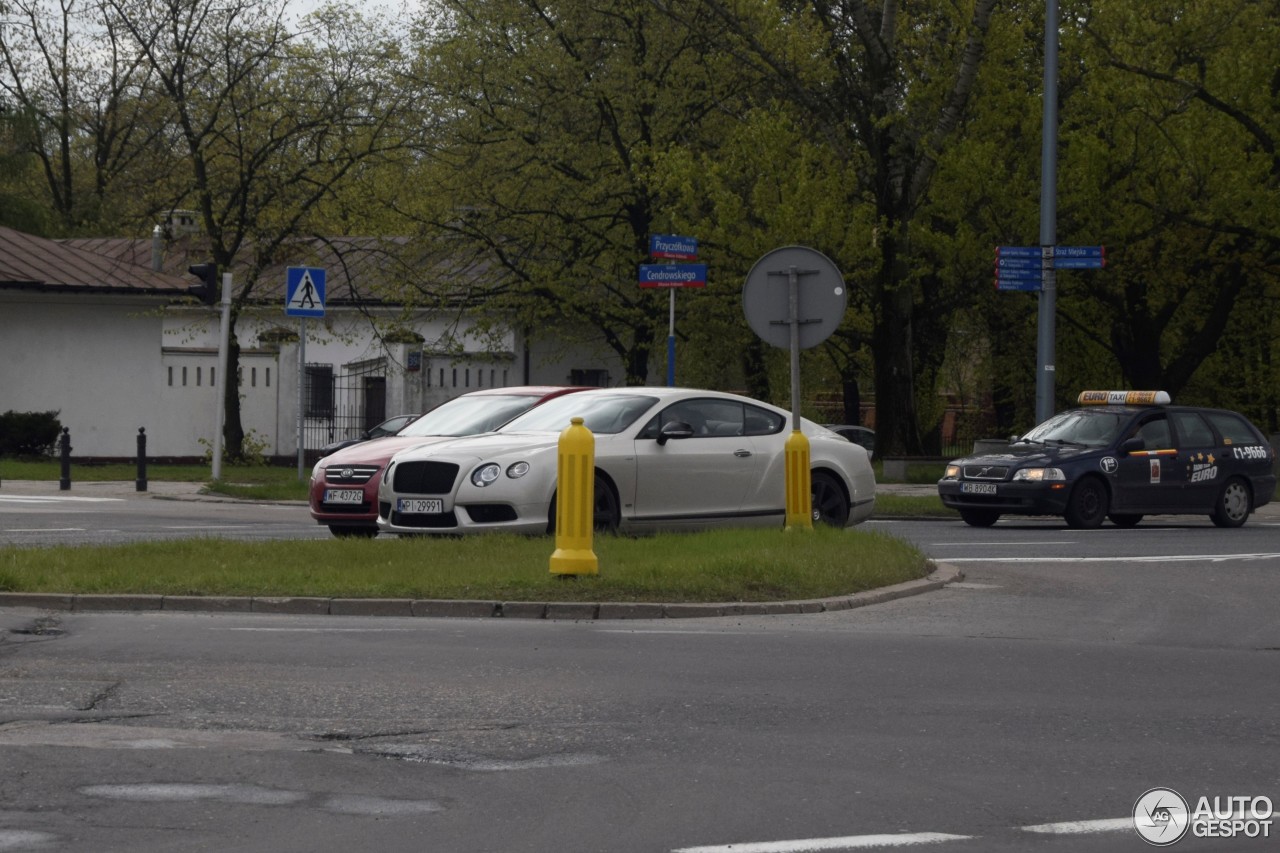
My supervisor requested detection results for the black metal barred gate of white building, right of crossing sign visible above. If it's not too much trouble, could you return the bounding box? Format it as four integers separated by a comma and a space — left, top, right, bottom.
302, 359, 387, 451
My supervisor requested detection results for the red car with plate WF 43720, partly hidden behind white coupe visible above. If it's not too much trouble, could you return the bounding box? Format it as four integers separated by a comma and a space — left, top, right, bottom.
311, 386, 585, 537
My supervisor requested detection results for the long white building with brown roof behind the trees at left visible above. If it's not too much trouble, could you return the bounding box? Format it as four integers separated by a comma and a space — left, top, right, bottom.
0, 222, 623, 459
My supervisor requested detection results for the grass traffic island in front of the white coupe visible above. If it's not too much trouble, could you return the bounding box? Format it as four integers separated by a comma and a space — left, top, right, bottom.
0, 528, 932, 602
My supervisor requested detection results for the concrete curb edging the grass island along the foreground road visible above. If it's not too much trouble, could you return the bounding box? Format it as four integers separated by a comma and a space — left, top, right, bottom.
0, 564, 964, 621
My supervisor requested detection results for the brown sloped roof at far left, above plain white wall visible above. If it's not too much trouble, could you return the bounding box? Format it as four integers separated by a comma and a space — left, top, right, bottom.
0, 227, 193, 296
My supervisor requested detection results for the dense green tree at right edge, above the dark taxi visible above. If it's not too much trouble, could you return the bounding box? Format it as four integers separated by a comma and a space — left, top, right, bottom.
1061, 0, 1280, 428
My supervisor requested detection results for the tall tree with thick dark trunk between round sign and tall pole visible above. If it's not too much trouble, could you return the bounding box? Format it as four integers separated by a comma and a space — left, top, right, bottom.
670, 0, 995, 453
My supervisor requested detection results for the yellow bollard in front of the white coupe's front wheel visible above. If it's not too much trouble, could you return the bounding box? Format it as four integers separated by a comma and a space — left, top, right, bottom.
552, 418, 599, 575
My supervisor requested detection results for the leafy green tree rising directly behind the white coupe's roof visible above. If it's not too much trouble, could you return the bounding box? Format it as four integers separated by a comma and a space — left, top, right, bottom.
404, 0, 742, 384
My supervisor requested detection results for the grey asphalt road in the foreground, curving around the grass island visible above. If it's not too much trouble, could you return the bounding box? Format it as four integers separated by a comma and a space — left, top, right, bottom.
0, 483, 1280, 853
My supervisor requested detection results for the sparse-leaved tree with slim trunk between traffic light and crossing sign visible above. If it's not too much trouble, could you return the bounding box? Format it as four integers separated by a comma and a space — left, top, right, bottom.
106, 0, 404, 460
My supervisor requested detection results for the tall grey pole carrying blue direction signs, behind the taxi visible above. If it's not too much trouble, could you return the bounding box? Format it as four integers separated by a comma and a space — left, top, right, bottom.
1036, 0, 1059, 423
